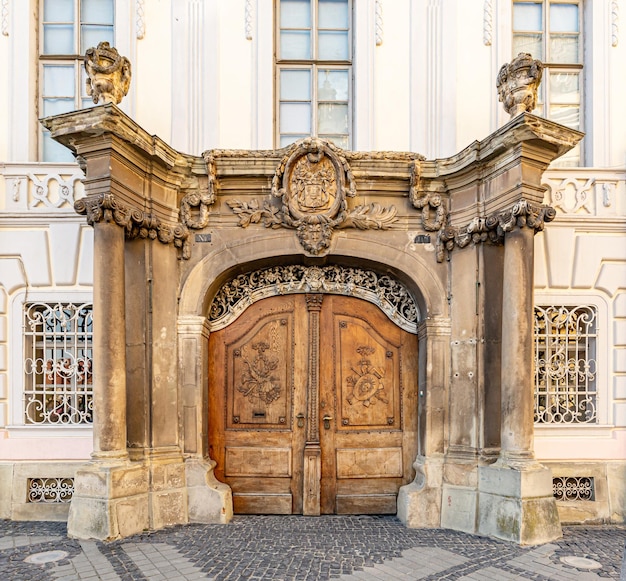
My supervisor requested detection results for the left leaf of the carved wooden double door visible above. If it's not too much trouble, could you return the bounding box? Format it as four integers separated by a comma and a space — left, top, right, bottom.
209, 295, 307, 514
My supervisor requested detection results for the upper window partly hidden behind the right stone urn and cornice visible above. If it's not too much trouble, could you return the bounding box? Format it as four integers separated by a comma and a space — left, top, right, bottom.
513, 0, 583, 167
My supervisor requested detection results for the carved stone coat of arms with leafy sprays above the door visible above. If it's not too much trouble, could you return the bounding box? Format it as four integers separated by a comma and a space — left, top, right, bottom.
227, 137, 397, 255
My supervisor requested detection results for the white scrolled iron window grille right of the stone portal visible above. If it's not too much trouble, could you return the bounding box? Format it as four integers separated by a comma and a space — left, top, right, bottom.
535, 305, 598, 424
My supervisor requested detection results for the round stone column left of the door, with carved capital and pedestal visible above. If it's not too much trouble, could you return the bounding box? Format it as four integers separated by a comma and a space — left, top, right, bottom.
67, 194, 149, 540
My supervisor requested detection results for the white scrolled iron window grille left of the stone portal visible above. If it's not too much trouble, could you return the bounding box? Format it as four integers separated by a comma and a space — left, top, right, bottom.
24, 303, 93, 425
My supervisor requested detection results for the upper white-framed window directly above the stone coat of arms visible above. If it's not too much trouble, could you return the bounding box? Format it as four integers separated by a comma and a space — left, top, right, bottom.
276, 0, 352, 149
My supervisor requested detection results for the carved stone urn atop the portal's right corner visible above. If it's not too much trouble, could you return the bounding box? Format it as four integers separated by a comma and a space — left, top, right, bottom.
496, 52, 543, 118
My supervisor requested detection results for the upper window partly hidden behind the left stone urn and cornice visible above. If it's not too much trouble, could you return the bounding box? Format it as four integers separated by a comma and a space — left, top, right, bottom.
39, 0, 115, 162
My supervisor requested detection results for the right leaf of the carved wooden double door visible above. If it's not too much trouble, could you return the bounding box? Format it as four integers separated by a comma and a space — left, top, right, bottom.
320, 296, 417, 514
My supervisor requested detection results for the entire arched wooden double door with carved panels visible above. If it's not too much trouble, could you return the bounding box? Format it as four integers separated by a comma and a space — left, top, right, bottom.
209, 294, 417, 515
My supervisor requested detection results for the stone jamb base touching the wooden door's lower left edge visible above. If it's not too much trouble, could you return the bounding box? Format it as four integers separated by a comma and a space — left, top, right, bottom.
185, 459, 233, 524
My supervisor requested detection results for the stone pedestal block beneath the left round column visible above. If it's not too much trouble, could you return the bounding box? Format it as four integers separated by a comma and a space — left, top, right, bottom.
67, 461, 150, 541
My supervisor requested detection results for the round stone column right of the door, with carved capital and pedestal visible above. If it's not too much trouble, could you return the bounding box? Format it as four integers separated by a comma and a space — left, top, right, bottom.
478, 212, 561, 545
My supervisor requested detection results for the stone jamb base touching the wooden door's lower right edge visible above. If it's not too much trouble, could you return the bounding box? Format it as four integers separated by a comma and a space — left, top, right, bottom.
398, 458, 442, 528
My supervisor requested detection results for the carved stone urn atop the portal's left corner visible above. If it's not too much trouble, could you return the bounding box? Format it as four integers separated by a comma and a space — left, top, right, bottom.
85, 42, 131, 105
